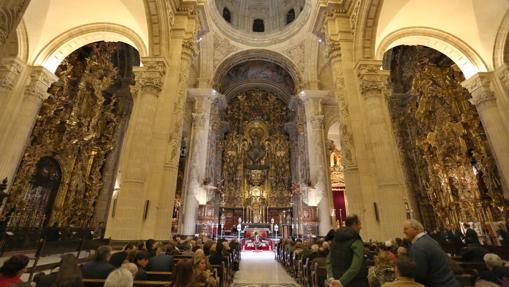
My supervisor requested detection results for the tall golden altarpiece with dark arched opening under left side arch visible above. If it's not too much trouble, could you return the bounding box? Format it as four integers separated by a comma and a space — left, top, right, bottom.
4, 42, 139, 233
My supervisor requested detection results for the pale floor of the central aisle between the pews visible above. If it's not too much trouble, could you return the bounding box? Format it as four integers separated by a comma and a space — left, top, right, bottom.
233, 251, 300, 287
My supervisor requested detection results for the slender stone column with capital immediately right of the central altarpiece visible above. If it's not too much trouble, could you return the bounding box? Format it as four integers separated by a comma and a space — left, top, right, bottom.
300, 90, 331, 235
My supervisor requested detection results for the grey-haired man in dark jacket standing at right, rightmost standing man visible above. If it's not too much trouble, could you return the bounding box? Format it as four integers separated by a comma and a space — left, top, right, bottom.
403, 219, 461, 287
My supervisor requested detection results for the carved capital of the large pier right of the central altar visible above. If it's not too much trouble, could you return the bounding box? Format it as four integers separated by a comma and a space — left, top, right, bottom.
355, 60, 390, 96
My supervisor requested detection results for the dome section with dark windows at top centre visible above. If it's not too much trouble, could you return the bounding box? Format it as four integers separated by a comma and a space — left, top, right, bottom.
215, 0, 306, 33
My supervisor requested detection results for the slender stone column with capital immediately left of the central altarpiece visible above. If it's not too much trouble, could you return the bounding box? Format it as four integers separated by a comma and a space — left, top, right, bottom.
182, 89, 217, 235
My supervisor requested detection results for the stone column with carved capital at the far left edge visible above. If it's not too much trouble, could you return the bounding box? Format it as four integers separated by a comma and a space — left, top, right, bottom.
0, 66, 57, 187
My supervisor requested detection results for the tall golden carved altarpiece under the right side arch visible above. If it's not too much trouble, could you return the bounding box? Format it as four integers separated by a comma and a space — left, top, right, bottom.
390, 47, 507, 231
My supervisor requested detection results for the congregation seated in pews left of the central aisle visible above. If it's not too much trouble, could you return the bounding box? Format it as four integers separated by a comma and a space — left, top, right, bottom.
0, 236, 240, 287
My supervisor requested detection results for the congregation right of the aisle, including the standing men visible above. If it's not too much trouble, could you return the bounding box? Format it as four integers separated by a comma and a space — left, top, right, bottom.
276, 215, 509, 287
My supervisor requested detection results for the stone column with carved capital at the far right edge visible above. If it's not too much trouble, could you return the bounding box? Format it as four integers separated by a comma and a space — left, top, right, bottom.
461, 73, 509, 199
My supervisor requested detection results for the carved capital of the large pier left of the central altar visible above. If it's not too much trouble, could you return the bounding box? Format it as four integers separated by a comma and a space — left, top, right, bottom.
133, 57, 168, 96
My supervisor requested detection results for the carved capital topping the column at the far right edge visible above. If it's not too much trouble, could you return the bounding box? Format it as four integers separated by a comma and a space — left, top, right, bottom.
461, 72, 496, 106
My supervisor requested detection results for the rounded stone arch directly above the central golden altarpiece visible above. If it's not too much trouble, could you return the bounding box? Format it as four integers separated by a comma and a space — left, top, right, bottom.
212, 49, 302, 91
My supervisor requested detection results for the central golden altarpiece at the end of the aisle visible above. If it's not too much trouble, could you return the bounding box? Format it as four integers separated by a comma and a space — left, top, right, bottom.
219, 89, 292, 227
